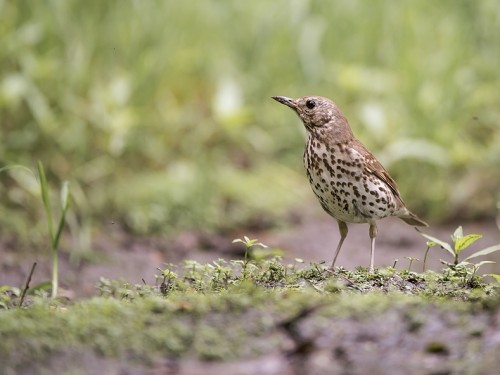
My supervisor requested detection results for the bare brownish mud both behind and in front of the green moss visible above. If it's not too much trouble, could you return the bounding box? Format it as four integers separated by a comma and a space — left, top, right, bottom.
0, 213, 500, 375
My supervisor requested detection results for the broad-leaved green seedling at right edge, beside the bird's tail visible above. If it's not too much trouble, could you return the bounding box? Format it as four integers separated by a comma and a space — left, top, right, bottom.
420, 226, 500, 271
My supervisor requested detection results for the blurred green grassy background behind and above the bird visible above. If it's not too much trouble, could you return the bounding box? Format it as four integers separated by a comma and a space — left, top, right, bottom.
0, 0, 500, 245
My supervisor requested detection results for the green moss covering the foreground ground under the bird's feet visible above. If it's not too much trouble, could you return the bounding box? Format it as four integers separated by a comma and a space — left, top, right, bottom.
0, 259, 500, 370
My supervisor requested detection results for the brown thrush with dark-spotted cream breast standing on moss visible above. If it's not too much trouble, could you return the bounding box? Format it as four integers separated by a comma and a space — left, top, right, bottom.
272, 96, 428, 272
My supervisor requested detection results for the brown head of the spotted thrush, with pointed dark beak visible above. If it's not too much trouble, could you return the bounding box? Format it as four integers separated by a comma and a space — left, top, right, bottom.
272, 96, 354, 143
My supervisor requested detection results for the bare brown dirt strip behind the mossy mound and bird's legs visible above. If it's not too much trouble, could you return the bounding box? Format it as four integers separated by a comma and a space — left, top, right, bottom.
0, 212, 500, 298
